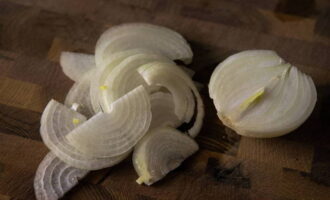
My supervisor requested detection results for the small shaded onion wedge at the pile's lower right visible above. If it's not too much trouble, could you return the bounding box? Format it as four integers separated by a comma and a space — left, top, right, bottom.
133, 127, 198, 185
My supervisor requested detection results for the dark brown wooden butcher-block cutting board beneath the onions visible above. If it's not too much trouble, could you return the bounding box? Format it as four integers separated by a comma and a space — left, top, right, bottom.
0, 0, 330, 200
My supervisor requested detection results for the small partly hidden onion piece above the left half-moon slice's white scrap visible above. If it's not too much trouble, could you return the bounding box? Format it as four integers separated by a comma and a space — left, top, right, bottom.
65, 70, 95, 118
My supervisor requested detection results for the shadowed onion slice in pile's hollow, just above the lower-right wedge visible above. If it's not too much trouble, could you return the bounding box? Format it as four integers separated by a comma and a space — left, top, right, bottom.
149, 92, 182, 130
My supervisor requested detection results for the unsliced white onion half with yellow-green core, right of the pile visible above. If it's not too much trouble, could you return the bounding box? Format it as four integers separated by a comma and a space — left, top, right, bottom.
209, 50, 317, 137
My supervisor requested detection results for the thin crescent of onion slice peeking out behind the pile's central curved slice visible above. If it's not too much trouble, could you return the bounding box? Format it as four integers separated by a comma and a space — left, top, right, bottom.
90, 49, 152, 113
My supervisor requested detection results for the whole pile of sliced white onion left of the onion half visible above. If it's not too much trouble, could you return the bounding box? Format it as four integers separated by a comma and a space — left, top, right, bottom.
34, 23, 204, 200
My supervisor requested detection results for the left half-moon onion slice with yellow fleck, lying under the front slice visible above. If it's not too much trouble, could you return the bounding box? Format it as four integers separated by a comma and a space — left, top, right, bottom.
40, 100, 129, 170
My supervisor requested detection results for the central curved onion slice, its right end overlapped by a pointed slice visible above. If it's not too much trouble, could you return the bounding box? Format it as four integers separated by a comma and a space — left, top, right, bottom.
99, 53, 173, 112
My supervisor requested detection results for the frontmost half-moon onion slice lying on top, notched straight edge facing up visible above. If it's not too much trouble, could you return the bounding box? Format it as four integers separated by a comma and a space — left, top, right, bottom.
66, 86, 151, 157
